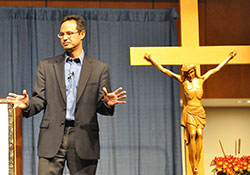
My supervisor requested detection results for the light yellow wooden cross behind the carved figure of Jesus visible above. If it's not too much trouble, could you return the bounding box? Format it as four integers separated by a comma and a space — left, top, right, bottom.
130, 0, 250, 175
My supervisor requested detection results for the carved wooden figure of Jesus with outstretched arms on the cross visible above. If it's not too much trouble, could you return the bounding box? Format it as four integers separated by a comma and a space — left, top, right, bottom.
144, 52, 236, 174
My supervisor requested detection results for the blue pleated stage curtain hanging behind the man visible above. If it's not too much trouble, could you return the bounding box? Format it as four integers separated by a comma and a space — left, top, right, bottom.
0, 7, 182, 175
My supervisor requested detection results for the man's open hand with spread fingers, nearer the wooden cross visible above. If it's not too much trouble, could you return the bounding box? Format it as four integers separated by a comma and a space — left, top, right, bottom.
102, 87, 127, 106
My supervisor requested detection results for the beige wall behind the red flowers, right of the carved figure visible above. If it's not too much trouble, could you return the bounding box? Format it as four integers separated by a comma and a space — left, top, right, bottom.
204, 107, 250, 175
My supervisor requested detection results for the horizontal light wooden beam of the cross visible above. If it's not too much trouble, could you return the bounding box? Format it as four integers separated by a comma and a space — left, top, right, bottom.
130, 45, 250, 66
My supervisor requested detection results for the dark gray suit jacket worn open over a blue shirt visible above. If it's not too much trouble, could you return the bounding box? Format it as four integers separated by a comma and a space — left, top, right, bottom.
23, 55, 114, 159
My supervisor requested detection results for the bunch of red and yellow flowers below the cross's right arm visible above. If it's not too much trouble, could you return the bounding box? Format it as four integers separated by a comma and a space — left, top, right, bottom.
210, 155, 250, 175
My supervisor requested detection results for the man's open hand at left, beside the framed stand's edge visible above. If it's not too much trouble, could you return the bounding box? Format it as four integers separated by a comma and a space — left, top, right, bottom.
7, 90, 29, 109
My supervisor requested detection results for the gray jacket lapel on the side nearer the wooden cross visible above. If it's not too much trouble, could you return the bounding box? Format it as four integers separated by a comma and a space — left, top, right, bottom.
76, 55, 93, 104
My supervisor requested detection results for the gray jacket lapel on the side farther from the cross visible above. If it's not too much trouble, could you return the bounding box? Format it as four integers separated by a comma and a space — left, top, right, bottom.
54, 54, 66, 103
